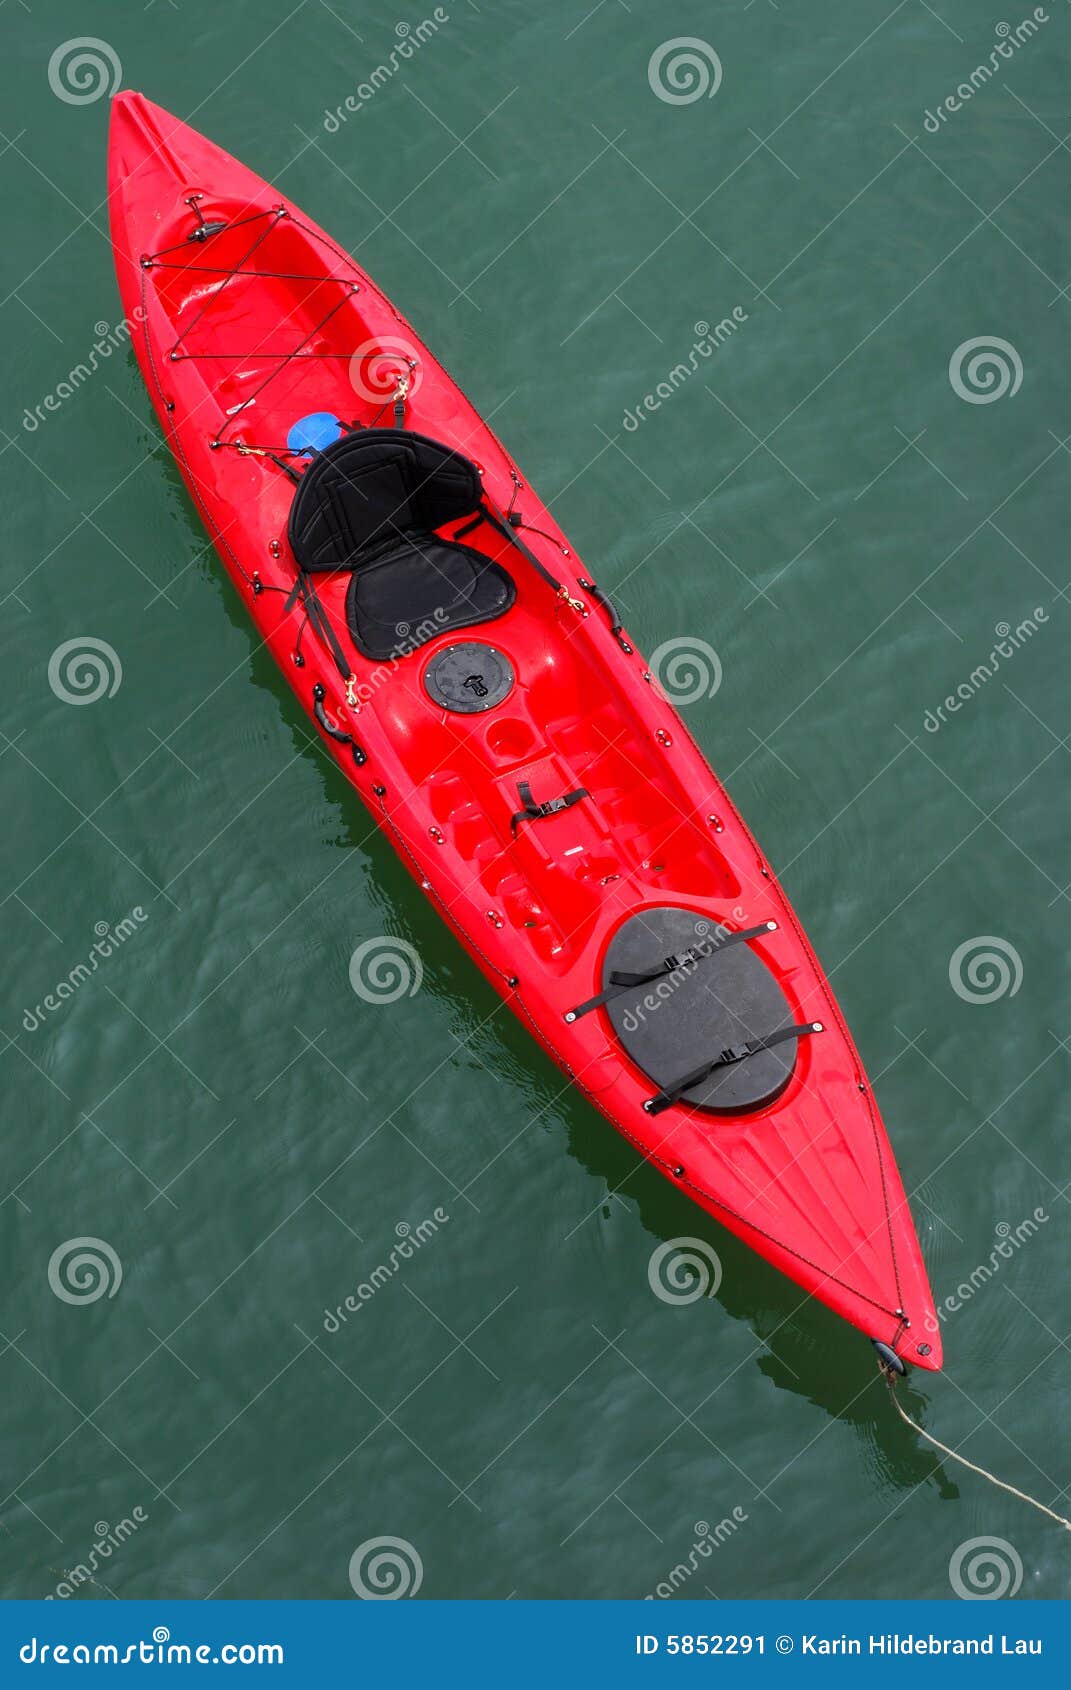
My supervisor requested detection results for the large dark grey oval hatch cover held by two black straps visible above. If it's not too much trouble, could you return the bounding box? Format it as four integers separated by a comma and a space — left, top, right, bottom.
603, 906, 799, 1115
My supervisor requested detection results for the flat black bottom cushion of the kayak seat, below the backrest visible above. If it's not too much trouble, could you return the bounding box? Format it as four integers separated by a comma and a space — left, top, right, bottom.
346, 534, 517, 662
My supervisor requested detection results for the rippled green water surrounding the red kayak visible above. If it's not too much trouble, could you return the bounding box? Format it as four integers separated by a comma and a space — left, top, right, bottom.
0, 0, 1071, 1599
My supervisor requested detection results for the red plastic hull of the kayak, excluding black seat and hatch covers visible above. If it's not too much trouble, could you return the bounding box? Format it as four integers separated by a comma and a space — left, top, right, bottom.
110, 93, 941, 1369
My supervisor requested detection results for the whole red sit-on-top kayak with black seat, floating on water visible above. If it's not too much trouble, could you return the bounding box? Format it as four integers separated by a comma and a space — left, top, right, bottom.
110, 93, 941, 1369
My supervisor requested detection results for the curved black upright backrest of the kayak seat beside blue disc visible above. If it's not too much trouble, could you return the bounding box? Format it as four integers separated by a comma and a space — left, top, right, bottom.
289, 428, 481, 573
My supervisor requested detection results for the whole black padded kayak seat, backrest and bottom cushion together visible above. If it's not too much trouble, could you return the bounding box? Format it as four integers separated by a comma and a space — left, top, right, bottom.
289, 428, 517, 662
